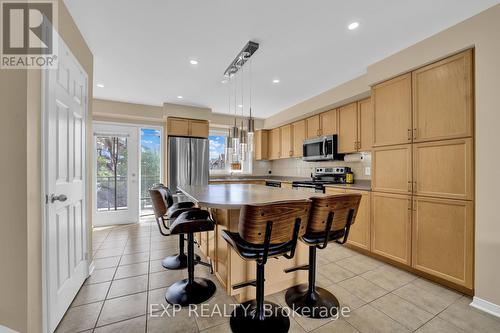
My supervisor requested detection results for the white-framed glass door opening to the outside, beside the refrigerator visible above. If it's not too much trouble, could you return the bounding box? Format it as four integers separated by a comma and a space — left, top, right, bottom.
93, 123, 139, 226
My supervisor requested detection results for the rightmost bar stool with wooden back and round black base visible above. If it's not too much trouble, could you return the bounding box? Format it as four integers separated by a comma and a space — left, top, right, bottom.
285, 194, 361, 318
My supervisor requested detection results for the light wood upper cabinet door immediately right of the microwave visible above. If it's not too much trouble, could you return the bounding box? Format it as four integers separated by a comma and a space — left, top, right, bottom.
338, 103, 358, 154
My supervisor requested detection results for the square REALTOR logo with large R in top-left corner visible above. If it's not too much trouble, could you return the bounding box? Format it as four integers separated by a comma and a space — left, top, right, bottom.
0, 0, 57, 69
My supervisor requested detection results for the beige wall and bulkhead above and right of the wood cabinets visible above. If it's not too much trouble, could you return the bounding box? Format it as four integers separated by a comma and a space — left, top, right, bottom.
265, 5, 500, 305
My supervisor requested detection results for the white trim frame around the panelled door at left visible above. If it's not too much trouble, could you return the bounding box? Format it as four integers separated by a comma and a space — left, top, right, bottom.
40, 39, 89, 333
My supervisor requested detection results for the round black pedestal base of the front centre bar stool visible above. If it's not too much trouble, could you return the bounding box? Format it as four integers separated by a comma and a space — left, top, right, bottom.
229, 301, 290, 333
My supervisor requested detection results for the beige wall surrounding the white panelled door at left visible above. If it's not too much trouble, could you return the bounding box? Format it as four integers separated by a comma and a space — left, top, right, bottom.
0, 0, 93, 332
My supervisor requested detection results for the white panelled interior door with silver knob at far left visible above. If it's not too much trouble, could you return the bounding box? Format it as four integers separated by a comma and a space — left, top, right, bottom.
42, 39, 88, 332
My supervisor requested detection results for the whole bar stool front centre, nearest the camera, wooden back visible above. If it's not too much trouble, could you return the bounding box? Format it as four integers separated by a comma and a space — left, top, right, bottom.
222, 200, 311, 333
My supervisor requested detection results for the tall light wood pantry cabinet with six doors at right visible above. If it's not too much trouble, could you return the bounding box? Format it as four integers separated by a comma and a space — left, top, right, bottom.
371, 50, 474, 289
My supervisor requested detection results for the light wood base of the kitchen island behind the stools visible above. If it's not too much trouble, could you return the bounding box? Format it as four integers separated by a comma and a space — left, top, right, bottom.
196, 207, 309, 303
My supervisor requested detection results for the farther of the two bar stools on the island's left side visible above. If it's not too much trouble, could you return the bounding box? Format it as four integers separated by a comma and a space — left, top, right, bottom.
150, 183, 201, 269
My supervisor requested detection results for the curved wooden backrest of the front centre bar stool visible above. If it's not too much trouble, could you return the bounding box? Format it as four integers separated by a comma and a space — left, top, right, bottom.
238, 200, 311, 245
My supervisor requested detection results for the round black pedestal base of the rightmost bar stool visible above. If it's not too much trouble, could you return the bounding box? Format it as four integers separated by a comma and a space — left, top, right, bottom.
285, 284, 340, 318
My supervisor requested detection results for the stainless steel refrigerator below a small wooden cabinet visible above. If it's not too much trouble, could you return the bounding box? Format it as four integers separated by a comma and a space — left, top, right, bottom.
168, 137, 209, 193
